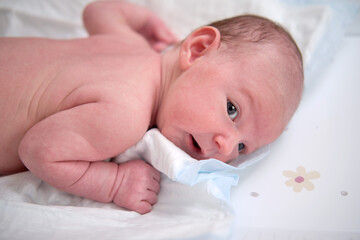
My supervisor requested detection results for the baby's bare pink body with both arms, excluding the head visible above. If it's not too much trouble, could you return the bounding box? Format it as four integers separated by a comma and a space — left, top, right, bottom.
0, 2, 175, 213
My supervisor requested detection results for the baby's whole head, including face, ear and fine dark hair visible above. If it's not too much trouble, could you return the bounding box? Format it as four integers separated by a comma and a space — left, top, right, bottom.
156, 15, 303, 162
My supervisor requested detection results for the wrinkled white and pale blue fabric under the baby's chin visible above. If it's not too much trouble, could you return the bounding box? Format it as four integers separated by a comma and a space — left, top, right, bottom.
115, 128, 268, 202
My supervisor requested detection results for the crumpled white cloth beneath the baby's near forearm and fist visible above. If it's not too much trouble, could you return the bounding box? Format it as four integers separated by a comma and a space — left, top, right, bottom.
0, 172, 234, 240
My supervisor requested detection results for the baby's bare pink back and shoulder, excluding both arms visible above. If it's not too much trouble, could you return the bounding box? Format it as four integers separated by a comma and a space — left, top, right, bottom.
0, 37, 159, 174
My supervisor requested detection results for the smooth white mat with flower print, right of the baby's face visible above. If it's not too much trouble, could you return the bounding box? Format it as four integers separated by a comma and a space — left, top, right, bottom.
232, 36, 360, 240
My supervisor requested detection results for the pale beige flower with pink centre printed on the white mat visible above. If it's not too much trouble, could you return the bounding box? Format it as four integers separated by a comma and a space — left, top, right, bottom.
283, 166, 320, 193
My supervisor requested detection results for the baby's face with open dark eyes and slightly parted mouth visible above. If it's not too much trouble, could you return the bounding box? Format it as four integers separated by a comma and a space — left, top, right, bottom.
157, 48, 286, 162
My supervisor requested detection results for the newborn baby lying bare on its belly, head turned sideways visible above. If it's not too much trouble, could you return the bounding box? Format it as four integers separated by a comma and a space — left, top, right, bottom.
0, 1, 303, 214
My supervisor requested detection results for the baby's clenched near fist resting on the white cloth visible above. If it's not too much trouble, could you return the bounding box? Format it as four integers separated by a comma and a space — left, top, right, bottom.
113, 160, 160, 214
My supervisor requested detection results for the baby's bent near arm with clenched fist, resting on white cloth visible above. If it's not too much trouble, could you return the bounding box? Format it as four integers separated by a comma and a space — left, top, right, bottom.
19, 102, 160, 214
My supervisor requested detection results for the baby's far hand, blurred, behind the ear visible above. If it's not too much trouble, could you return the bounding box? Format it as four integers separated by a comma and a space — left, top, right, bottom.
138, 13, 177, 52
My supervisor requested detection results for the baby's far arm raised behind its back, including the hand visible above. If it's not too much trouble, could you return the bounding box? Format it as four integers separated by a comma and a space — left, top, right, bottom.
83, 1, 177, 51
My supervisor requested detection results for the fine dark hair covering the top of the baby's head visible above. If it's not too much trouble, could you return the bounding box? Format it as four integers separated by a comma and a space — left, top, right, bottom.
209, 15, 304, 122
